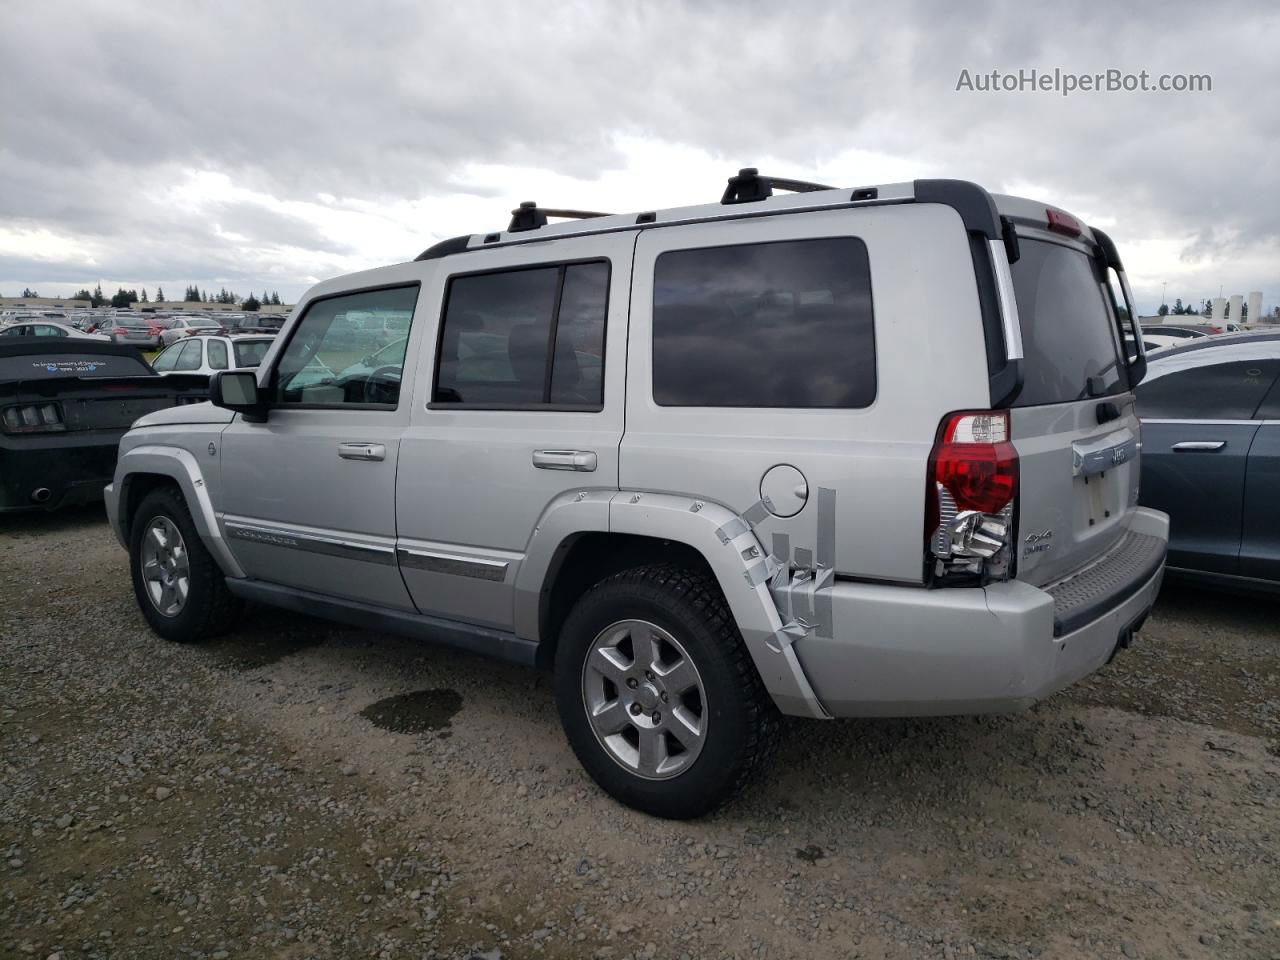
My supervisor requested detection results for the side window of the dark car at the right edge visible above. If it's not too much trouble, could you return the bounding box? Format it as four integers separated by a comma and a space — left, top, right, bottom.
1138, 358, 1280, 420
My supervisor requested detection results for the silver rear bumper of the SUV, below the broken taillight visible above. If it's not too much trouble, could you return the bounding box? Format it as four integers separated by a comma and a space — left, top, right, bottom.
795, 509, 1169, 717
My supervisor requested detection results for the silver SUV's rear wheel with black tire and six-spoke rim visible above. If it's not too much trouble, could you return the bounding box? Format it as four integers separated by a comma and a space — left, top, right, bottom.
556, 566, 777, 819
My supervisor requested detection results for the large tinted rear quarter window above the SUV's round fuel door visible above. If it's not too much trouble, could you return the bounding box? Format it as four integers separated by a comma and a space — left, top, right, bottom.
653, 237, 876, 408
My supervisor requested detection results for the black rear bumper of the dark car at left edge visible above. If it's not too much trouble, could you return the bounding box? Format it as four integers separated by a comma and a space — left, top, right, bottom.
0, 429, 124, 513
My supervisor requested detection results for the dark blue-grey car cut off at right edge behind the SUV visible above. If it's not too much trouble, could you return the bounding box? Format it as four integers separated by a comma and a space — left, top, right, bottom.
1138, 332, 1280, 589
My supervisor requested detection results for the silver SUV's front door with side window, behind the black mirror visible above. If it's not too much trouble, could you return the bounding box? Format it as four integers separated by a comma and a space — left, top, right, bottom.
219, 273, 428, 609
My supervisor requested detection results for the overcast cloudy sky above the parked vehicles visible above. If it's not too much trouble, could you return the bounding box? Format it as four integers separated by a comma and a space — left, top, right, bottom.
0, 0, 1280, 312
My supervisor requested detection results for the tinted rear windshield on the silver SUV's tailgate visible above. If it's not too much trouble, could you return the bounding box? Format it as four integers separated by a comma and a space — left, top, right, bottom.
1011, 237, 1128, 407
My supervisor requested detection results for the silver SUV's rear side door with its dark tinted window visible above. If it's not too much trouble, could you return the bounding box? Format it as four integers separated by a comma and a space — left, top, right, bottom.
396, 234, 635, 630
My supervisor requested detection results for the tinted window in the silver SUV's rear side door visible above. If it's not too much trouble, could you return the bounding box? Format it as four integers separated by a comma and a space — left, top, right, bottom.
433, 261, 609, 408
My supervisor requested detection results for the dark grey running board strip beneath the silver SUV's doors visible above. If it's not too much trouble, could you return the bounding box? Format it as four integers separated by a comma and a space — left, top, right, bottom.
227, 577, 538, 667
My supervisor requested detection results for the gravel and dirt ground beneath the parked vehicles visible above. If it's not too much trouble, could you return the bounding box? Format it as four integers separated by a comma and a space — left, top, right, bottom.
0, 509, 1280, 960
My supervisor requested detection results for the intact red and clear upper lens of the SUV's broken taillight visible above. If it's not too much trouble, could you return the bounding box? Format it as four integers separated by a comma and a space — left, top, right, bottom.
932, 411, 1018, 513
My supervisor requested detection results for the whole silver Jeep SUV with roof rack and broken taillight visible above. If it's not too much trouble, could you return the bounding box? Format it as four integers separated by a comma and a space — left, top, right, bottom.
108, 169, 1167, 817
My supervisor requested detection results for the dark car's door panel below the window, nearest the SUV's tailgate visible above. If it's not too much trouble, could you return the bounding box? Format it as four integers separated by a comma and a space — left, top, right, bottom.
1140, 420, 1258, 573
